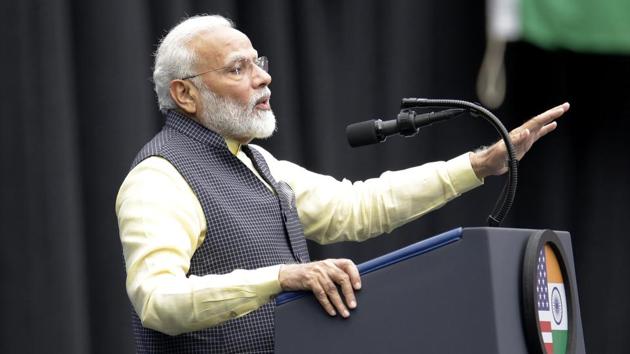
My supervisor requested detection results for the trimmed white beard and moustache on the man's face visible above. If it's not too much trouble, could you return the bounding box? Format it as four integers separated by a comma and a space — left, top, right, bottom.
197, 82, 276, 142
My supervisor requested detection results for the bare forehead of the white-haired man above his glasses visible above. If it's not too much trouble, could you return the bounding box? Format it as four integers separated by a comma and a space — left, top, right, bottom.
190, 27, 257, 66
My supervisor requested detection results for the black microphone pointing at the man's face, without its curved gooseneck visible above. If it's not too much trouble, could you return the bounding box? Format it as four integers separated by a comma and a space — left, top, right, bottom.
346, 108, 466, 147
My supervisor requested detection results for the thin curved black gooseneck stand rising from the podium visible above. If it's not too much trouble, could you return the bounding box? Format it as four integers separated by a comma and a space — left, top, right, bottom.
401, 98, 518, 226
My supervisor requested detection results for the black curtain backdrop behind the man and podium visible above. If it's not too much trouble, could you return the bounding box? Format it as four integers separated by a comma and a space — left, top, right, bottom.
0, 0, 630, 353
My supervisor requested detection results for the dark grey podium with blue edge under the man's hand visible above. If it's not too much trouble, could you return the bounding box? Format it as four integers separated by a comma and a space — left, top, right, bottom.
275, 227, 585, 354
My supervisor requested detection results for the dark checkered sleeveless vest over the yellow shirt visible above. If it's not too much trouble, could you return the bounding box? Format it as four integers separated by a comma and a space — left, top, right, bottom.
132, 111, 309, 353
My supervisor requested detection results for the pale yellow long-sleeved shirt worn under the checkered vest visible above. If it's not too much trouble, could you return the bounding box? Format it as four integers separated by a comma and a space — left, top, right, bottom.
116, 146, 482, 335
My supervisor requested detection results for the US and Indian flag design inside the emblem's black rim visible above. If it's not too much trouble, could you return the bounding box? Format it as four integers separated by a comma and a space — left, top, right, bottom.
536, 244, 568, 354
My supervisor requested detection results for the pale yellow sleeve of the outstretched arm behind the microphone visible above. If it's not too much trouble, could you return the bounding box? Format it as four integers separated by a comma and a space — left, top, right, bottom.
256, 147, 483, 244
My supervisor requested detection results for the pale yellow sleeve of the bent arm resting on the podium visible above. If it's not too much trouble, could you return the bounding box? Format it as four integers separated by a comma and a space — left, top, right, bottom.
116, 157, 281, 335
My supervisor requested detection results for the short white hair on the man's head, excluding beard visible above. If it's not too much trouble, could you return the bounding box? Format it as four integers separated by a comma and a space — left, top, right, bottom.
153, 15, 234, 112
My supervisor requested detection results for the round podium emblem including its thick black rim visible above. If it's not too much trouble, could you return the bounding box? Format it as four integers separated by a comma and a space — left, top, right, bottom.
522, 230, 576, 354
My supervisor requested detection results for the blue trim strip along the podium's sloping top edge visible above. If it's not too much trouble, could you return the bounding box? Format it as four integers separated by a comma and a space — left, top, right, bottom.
276, 227, 463, 305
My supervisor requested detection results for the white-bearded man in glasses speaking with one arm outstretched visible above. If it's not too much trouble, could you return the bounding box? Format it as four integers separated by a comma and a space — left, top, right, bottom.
116, 16, 568, 352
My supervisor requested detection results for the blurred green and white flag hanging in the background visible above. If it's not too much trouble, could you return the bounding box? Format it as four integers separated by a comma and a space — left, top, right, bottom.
477, 0, 630, 108
